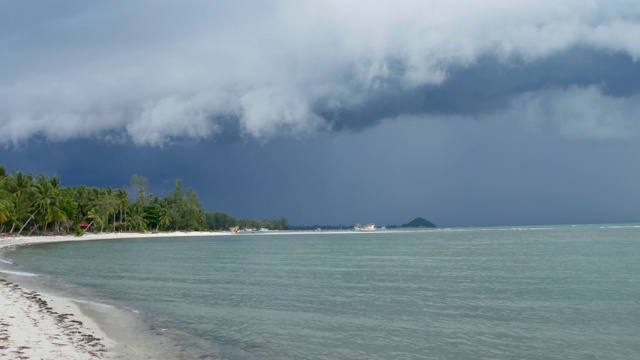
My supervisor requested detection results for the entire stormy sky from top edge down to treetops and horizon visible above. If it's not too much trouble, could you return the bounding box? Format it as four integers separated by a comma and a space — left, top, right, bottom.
0, 0, 640, 226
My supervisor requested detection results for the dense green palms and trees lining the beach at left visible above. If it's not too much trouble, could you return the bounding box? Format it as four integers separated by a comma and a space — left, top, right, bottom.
0, 165, 288, 235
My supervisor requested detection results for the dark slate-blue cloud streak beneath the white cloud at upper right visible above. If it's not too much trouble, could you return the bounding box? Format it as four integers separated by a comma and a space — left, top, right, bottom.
319, 47, 640, 130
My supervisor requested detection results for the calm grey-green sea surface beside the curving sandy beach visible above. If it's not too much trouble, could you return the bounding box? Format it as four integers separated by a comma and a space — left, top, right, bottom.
2, 225, 640, 360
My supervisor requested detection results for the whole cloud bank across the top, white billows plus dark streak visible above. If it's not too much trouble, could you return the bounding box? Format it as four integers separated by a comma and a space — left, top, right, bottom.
0, 0, 640, 146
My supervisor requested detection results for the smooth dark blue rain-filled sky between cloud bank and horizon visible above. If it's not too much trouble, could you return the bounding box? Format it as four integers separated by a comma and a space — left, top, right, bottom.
0, 114, 640, 226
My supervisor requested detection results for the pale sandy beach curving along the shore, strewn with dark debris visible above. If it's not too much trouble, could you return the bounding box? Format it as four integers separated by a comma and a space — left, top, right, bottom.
0, 232, 228, 359
